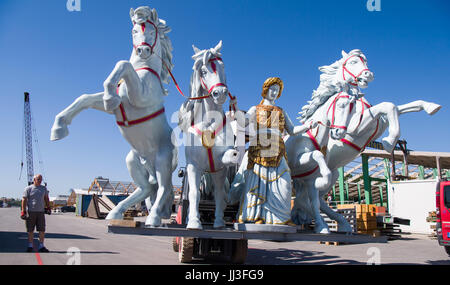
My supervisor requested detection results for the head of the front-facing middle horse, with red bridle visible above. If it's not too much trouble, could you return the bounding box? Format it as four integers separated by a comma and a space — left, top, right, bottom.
191, 41, 229, 105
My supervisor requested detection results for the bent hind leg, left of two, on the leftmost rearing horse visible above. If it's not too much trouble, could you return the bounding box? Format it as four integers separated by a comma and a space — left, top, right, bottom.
106, 151, 152, 220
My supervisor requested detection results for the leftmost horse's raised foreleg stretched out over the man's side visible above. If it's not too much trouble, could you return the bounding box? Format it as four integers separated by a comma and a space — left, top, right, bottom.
50, 92, 111, 141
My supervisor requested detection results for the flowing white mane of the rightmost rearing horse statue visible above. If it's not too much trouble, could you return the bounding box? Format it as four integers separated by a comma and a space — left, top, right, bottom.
297, 49, 366, 123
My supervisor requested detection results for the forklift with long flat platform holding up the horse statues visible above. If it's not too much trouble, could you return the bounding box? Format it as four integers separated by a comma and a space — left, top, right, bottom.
108, 166, 387, 264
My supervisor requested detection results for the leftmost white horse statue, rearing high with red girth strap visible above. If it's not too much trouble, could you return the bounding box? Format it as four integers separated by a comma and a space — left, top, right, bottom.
50, 7, 178, 226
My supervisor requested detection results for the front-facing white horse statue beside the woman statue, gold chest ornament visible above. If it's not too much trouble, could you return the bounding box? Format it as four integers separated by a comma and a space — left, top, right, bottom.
179, 41, 239, 229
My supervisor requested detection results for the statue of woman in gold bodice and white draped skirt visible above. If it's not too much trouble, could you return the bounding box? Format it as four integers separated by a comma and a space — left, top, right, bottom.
233, 77, 316, 224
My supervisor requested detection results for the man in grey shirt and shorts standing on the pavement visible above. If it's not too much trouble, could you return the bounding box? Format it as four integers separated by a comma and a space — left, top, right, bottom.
21, 174, 50, 252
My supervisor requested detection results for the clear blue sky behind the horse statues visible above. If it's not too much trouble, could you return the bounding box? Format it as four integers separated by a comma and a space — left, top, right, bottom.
0, 0, 450, 197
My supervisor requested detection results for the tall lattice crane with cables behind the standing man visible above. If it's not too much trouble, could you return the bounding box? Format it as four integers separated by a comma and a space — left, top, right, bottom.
19, 92, 46, 185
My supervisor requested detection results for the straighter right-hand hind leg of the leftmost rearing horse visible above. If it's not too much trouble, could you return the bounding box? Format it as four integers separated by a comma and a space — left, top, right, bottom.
145, 149, 174, 227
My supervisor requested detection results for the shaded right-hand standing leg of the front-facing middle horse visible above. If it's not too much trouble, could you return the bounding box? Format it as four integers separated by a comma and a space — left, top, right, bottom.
211, 168, 227, 228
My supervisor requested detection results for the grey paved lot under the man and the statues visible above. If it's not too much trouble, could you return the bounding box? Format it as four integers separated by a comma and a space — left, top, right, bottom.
0, 208, 450, 265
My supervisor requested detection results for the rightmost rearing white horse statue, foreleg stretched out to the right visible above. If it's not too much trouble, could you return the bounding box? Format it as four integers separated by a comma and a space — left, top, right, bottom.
292, 50, 441, 232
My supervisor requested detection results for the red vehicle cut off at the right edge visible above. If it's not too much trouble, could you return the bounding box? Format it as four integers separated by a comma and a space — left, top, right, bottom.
436, 181, 450, 256
